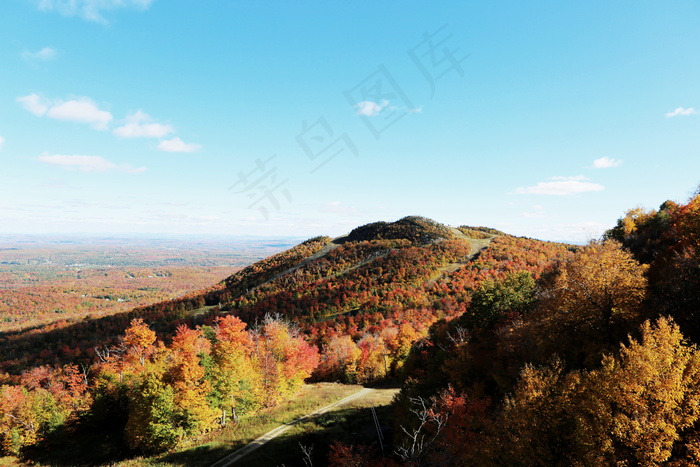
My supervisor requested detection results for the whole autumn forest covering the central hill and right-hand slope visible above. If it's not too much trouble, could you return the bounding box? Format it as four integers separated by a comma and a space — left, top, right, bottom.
0, 197, 700, 465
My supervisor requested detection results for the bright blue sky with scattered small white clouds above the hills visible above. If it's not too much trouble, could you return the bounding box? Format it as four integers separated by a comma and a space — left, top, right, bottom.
0, 0, 700, 242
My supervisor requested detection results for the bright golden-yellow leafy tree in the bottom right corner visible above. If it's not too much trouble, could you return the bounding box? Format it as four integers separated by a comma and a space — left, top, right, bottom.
577, 318, 700, 466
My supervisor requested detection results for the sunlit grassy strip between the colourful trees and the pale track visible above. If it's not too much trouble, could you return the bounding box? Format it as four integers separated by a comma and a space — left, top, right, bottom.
108, 383, 362, 467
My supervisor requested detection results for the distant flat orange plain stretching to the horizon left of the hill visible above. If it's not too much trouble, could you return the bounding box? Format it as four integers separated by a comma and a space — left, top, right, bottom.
0, 236, 295, 331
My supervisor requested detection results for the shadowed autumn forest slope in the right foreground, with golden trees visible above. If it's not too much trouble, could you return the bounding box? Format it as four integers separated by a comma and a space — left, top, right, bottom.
378, 196, 700, 466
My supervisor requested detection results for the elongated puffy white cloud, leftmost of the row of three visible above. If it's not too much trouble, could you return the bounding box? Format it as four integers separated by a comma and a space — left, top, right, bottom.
16, 94, 112, 130
